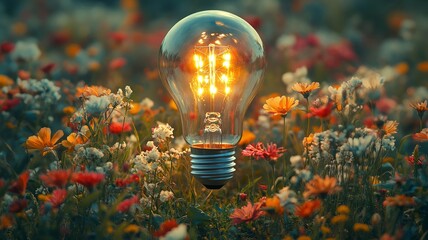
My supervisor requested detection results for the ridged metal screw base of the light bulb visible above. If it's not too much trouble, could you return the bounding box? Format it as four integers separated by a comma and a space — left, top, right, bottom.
190, 147, 236, 189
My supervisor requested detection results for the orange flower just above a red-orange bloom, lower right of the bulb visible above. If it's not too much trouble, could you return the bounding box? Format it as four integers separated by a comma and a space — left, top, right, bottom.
303, 175, 341, 198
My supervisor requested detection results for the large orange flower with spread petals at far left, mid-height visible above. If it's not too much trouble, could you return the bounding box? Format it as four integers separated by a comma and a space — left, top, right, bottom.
25, 127, 64, 156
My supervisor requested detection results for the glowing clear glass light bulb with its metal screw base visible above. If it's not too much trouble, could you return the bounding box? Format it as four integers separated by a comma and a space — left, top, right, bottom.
159, 11, 266, 189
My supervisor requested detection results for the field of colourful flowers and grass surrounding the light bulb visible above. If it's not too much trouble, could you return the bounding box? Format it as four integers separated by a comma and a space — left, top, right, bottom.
0, 0, 428, 240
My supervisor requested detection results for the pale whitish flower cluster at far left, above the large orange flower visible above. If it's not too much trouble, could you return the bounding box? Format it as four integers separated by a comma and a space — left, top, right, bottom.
17, 79, 61, 109
